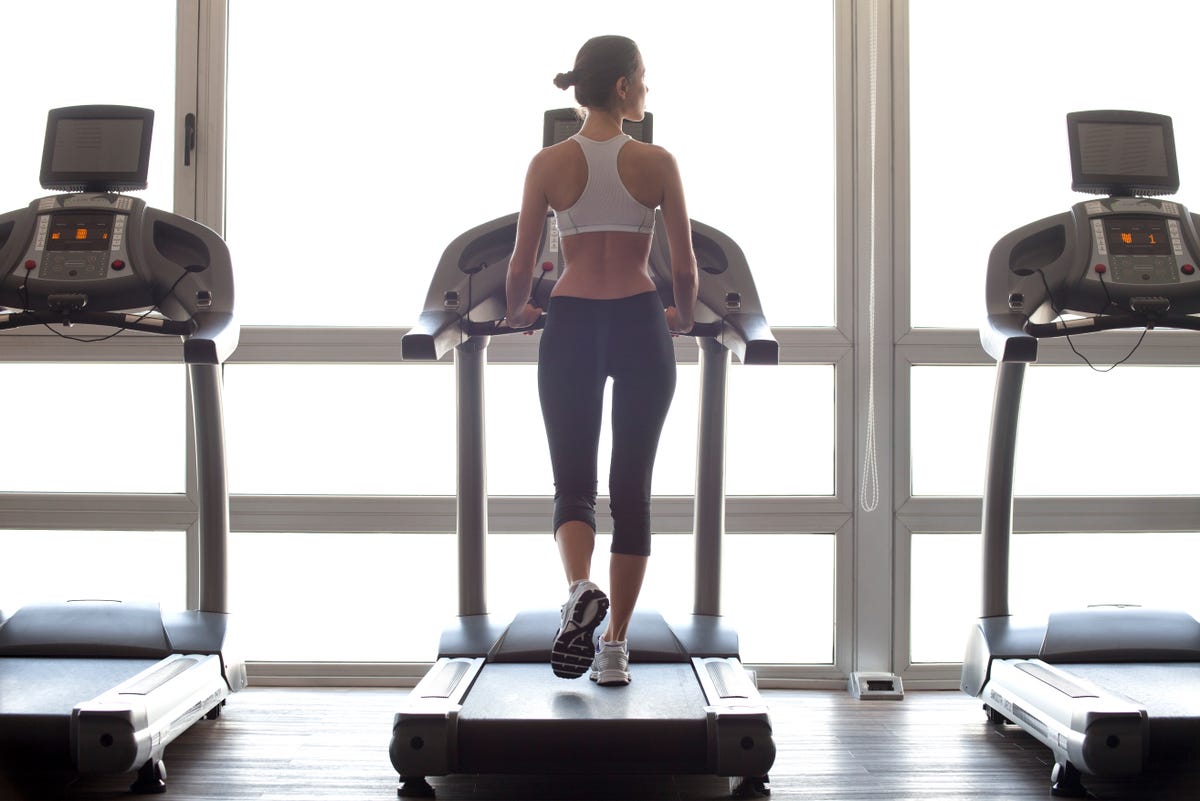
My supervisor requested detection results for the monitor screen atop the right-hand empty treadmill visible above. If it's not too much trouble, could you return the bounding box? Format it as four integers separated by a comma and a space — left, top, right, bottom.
1067, 112, 1180, 195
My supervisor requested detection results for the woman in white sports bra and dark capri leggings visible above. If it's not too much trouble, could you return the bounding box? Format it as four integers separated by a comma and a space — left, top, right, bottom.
505, 36, 697, 685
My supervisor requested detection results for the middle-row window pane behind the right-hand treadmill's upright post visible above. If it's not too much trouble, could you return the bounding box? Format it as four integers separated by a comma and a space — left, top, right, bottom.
912, 365, 1200, 496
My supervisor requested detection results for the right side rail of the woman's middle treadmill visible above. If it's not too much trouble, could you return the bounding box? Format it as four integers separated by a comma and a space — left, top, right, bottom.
691, 657, 775, 777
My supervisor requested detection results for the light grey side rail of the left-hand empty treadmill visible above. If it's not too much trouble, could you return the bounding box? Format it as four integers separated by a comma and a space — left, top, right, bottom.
71, 655, 229, 773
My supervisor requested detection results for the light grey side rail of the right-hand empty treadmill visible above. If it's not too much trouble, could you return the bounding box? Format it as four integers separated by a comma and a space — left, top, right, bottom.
982, 660, 1150, 778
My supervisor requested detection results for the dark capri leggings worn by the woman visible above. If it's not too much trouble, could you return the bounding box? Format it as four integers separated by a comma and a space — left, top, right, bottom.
538, 291, 676, 556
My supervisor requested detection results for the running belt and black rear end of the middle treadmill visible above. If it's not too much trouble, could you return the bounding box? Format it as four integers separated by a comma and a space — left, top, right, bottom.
456, 663, 709, 773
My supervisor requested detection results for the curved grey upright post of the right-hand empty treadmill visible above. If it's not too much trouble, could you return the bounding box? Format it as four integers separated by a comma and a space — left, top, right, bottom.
982, 361, 1025, 618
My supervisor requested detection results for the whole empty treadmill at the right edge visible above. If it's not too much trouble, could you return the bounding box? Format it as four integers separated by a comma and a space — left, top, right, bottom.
961, 112, 1200, 795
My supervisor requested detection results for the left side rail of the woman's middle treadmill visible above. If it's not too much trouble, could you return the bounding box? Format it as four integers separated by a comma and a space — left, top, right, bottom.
388, 657, 484, 778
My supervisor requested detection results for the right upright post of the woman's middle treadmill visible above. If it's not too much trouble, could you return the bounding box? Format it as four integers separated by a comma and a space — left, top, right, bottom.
694, 337, 730, 616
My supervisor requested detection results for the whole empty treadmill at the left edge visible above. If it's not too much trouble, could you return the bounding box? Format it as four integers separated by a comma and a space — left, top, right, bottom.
0, 106, 246, 793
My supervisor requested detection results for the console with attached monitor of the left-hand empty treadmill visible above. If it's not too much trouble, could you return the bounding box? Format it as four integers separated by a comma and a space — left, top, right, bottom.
0, 106, 238, 363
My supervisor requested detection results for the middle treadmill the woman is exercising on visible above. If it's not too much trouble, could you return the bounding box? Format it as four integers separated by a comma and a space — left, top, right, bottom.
390, 109, 779, 796
